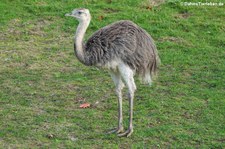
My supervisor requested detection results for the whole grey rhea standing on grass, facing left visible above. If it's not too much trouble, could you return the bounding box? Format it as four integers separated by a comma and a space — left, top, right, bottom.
65, 8, 160, 137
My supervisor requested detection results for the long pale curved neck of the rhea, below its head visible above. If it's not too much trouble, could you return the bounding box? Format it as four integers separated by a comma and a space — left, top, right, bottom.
75, 20, 90, 65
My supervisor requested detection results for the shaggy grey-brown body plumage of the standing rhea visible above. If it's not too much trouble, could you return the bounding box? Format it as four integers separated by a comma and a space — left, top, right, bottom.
74, 20, 160, 81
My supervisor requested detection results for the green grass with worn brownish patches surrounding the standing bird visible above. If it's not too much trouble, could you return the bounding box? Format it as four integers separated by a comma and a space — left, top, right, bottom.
0, 0, 225, 148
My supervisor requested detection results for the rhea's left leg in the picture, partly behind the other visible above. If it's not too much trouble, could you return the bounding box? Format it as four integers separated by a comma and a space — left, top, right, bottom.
109, 72, 124, 133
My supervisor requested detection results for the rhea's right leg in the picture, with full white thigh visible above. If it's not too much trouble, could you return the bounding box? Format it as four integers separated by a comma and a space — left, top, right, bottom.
118, 64, 136, 137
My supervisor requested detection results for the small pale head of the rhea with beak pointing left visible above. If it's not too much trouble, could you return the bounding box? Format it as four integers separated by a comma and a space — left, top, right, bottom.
65, 8, 91, 22
